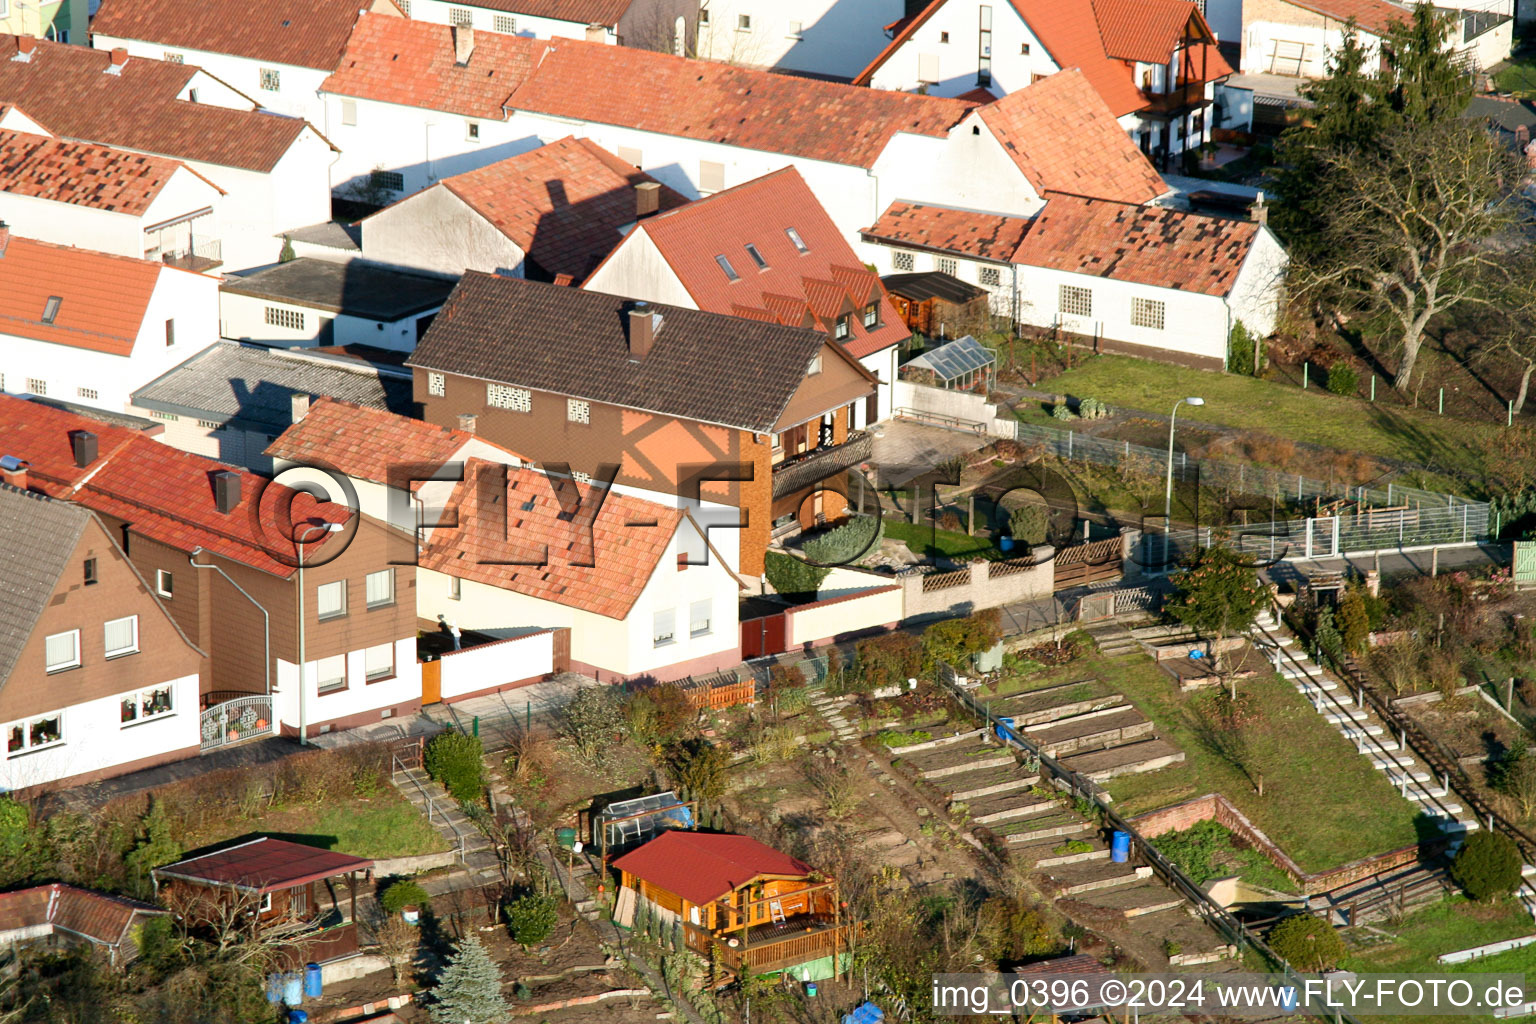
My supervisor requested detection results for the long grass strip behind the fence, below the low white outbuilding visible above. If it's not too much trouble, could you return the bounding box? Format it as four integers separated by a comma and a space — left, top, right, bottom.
1021, 356, 1502, 491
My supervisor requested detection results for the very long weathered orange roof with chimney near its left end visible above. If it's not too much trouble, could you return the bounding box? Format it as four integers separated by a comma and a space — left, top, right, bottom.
323, 14, 970, 167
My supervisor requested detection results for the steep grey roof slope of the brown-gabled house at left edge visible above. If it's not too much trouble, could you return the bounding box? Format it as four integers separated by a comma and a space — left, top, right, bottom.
0, 484, 91, 686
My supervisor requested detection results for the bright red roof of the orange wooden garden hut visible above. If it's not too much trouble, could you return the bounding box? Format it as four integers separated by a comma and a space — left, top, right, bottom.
613, 829, 811, 906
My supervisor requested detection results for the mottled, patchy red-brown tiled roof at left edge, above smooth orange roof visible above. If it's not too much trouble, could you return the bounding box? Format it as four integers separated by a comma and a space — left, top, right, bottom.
0, 132, 196, 216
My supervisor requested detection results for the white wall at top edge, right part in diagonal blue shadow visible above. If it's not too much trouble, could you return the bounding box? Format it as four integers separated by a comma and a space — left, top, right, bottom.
697, 0, 903, 78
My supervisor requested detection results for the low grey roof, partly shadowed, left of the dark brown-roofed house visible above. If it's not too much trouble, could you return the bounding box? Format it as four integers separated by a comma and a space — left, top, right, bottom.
134, 341, 415, 434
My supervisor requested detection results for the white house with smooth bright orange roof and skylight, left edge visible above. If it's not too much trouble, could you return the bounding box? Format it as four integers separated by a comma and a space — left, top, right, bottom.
0, 226, 218, 413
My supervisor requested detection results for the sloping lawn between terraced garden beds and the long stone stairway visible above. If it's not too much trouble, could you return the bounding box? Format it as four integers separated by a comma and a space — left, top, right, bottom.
1013, 654, 1418, 872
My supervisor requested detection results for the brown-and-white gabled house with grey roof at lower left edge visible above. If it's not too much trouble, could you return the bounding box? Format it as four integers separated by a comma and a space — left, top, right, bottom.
0, 482, 207, 792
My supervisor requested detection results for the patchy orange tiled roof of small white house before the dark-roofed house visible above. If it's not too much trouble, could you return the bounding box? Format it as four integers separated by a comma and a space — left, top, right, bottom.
418, 459, 684, 619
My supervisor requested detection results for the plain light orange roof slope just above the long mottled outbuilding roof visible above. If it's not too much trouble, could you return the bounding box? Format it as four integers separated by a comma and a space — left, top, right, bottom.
977, 70, 1167, 203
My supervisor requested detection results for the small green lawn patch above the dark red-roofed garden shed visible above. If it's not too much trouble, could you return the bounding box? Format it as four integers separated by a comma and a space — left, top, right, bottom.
186, 789, 449, 860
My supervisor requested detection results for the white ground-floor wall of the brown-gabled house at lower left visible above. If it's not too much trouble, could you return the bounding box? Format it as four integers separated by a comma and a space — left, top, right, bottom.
0, 674, 201, 792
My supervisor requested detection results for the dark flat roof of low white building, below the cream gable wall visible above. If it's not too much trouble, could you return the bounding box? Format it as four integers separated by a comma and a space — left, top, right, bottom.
220, 258, 453, 322
